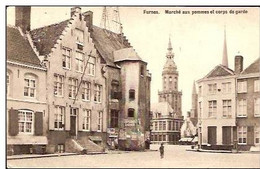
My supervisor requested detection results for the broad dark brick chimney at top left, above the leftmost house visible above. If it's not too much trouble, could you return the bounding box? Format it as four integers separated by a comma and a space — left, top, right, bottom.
15, 6, 31, 34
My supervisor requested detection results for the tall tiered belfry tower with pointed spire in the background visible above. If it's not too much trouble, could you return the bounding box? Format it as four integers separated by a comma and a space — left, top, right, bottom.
158, 38, 182, 117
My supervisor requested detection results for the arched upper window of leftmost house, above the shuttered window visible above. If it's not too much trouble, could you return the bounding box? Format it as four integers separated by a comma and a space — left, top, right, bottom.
24, 75, 36, 97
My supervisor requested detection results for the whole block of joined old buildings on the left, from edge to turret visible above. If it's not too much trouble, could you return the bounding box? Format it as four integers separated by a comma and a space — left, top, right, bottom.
6, 6, 151, 154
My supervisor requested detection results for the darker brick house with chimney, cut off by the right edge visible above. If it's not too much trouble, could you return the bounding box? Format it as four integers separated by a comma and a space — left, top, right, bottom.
235, 56, 260, 151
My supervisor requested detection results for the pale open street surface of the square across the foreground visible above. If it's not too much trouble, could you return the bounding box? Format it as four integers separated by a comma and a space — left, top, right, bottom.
7, 145, 260, 168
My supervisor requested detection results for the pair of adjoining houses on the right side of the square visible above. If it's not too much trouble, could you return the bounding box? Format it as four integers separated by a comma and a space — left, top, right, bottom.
195, 29, 260, 150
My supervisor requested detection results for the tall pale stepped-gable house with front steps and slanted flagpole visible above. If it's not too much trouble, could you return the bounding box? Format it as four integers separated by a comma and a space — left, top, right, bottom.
30, 7, 107, 152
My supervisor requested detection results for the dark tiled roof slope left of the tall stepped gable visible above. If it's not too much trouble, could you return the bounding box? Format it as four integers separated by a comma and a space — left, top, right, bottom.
30, 19, 70, 55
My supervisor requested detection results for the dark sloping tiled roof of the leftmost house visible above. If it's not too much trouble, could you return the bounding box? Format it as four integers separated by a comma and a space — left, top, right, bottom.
7, 26, 41, 67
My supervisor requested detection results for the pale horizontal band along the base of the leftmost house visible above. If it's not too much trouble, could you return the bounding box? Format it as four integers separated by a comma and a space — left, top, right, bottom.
7, 135, 48, 145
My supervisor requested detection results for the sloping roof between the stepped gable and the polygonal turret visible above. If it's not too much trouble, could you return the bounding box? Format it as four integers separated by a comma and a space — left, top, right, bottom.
91, 25, 131, 66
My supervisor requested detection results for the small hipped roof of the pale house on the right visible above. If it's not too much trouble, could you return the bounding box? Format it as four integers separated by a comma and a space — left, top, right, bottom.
204, 65, 234, 78
